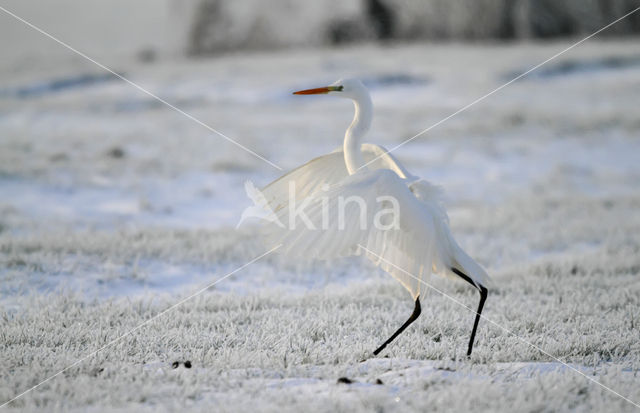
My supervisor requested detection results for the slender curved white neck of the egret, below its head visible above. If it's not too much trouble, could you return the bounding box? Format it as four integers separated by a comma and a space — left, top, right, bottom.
343, 92, 373, 175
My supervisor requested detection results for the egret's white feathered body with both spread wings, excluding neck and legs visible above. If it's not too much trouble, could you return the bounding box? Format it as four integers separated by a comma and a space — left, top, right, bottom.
262, 144, 490, 299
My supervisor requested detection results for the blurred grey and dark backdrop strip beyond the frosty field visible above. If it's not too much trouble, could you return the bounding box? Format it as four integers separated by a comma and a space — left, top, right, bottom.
0, 0, 640, 64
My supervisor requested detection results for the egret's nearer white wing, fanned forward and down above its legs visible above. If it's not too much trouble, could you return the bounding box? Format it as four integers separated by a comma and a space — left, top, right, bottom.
264, 169, 452, 299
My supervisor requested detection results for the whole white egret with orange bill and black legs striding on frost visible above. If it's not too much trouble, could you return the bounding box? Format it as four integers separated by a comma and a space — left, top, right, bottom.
252, 79, 489, 355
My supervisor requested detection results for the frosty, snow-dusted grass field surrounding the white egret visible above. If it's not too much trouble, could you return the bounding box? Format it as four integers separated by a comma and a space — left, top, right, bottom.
0, 39, 640, 412
